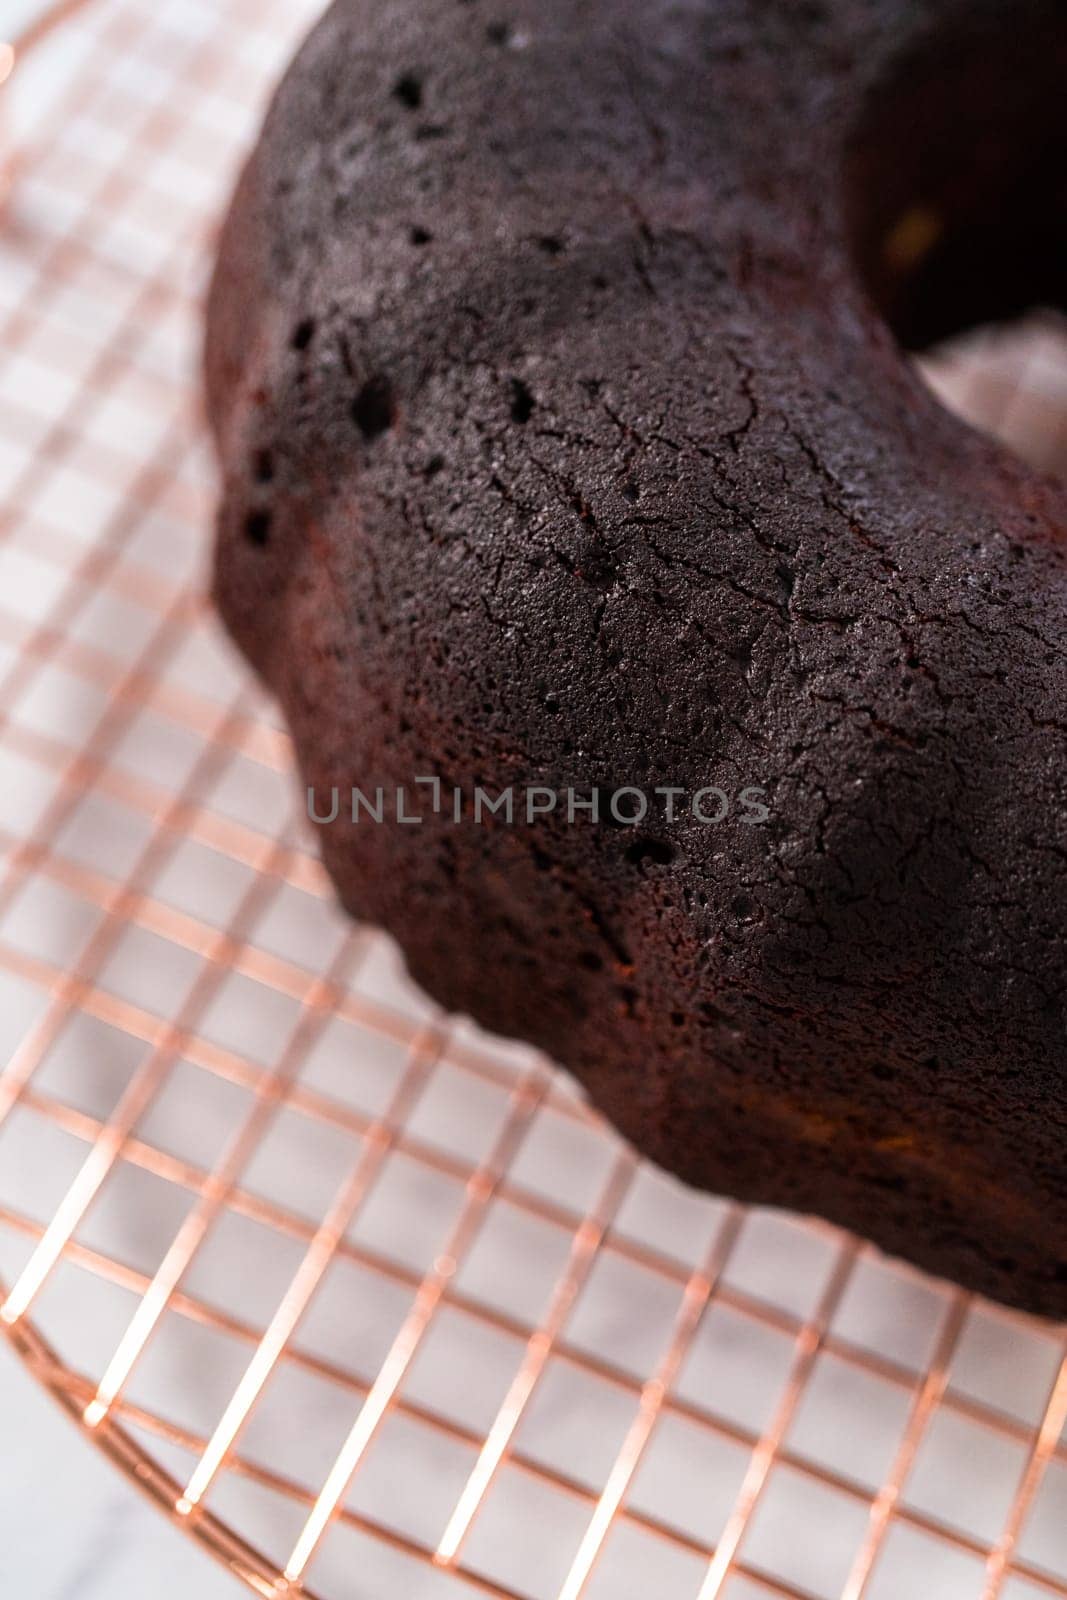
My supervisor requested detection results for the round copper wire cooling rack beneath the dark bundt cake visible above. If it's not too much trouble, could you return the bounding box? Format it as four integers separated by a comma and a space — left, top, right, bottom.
0, 0, 1067, 1600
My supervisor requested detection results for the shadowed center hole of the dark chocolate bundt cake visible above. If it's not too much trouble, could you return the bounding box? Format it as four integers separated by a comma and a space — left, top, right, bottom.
843, 0, 1067, 477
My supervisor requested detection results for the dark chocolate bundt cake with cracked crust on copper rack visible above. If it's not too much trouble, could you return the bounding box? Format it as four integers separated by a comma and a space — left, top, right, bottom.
206, 0, 1067, 1317
